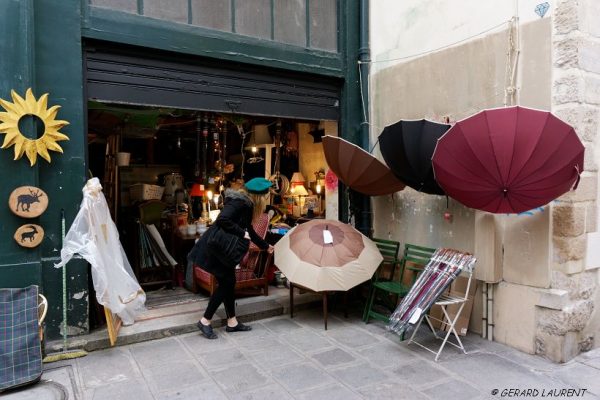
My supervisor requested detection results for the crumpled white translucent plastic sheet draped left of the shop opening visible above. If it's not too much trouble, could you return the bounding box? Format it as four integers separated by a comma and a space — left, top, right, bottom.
55, 178, 146, 325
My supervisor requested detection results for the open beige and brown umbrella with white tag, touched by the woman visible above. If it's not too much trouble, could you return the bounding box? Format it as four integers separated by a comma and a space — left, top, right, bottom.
275, 219, 383, 292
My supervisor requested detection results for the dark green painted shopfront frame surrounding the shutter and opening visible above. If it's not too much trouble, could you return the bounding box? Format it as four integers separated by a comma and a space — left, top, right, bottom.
0, 0, 370, 339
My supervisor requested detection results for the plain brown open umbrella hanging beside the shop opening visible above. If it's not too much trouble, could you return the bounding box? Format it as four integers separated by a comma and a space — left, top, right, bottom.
323, 135, 405, 196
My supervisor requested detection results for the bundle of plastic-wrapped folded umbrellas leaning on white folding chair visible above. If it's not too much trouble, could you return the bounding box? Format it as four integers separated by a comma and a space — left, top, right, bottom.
388, 248, 476, 335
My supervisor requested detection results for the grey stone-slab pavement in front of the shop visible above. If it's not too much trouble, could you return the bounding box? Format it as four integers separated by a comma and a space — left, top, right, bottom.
5, 309, 600, 400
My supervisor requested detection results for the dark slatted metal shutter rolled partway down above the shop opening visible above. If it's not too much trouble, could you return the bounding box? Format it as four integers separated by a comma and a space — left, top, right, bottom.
85, 44, 341, 120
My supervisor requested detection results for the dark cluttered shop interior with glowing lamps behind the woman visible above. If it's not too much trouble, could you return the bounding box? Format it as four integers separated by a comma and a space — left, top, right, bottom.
88, 101, 337, 306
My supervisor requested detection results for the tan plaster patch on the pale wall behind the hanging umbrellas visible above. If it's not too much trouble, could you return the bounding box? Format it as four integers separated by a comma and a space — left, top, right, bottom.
371, 19, 552, 353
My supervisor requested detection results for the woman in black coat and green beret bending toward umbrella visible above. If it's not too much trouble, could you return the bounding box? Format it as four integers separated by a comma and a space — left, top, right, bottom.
188, 183, 273, 339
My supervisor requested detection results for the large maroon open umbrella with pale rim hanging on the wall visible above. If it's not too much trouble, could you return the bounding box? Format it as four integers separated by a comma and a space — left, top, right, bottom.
432, 106, 584, 213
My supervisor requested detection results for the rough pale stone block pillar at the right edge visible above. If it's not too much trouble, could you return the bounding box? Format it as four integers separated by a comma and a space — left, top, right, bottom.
536, 0, 600, 362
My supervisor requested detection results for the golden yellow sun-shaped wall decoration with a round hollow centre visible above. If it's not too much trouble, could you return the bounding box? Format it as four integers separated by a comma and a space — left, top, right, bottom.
0, 88, 69, 166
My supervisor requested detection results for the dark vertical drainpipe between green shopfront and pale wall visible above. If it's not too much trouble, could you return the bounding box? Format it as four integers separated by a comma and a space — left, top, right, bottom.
357, 0, 373, 237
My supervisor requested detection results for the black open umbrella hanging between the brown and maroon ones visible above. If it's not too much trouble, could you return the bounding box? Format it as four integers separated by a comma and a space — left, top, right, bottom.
379, 119, 450, 194
